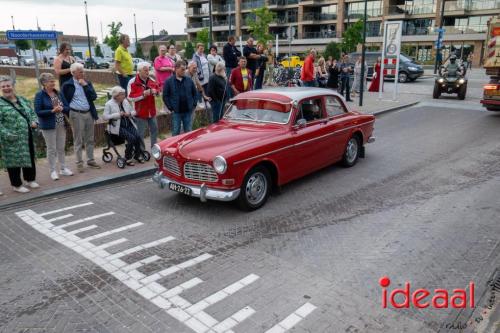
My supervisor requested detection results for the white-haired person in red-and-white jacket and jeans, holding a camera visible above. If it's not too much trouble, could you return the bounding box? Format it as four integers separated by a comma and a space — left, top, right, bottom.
128, 62, 160, 150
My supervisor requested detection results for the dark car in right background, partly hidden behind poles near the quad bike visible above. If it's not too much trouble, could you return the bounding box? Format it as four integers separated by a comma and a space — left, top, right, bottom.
349, 52, 424, 83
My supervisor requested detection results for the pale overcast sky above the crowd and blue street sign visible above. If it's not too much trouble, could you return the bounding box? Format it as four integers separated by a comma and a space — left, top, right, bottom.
0, 0, 186, 40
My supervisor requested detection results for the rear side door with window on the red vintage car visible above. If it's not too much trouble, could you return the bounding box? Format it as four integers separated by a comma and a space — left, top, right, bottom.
324, 95, 354, 163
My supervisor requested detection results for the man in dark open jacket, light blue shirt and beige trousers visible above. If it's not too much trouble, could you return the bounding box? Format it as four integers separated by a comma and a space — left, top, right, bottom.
61, 63, 101, 172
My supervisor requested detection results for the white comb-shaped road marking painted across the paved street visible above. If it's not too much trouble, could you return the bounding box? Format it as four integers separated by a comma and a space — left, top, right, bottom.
16, 206, 316, 333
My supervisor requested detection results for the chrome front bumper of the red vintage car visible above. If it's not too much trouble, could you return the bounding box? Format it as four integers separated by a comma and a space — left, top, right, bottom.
153, 171, 240, 202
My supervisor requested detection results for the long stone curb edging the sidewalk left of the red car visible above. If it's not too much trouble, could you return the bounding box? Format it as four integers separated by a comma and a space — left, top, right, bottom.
0, 166, 156, 210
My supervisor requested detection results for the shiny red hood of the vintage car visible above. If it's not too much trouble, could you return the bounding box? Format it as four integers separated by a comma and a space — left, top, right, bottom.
177, 121, 285, 162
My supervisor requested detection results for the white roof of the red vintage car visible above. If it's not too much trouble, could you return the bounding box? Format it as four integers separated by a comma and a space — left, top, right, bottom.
234, 87, 340, 103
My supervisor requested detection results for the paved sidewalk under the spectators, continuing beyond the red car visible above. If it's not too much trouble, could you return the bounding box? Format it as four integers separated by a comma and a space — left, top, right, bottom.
0, 92, 418, 209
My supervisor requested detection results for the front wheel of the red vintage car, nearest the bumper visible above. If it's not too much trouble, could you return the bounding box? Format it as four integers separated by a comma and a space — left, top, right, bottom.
238, 166, 271, 211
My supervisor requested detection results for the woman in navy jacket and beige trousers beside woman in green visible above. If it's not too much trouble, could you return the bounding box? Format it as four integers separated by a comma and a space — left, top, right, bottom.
35, 73, 73, 180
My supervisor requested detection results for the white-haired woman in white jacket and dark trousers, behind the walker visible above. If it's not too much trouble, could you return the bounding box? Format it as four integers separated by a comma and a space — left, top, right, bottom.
102, 86, 144, 165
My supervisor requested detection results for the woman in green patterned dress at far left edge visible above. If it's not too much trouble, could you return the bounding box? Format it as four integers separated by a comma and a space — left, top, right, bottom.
0, 76, 40, 193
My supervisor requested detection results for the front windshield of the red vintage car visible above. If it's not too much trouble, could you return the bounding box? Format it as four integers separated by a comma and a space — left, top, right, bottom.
224, 99, 291, 124
